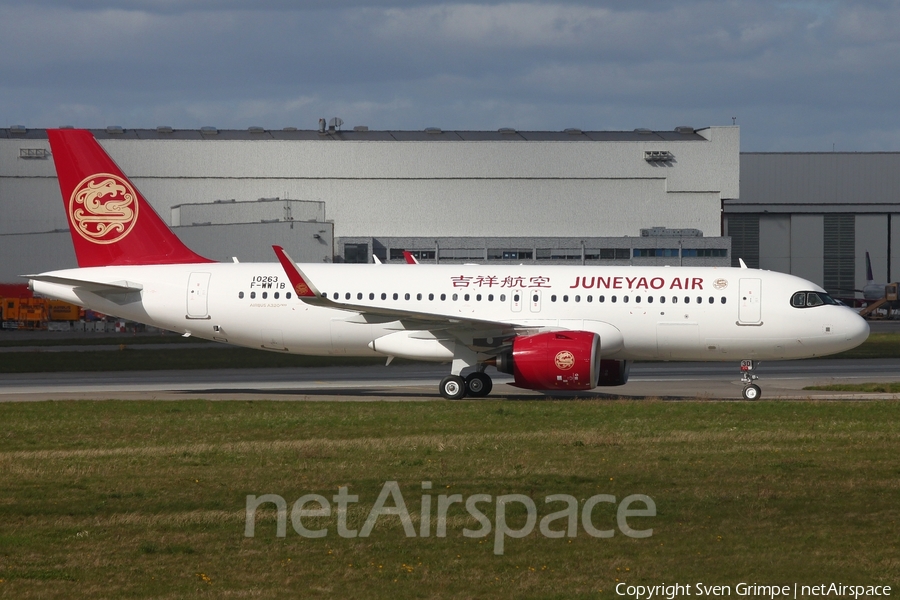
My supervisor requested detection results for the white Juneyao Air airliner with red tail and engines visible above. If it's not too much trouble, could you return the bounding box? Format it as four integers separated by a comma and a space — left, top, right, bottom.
28, 130, 869, 399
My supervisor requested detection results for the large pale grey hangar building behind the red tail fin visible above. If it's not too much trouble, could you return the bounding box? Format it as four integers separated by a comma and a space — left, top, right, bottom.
0, 127, 740, 281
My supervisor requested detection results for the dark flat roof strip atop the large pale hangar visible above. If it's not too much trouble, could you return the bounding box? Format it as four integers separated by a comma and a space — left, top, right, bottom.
0, 126, 706, 142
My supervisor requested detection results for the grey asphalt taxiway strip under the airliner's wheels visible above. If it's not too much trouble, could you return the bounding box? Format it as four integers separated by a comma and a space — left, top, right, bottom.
0, 359, 900, 402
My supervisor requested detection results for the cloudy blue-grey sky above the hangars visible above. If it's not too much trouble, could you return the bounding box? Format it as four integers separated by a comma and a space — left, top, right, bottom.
0, 0, 900, 151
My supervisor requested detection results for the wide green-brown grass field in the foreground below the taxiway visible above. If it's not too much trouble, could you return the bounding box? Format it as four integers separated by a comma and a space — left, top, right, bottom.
0, 400, 900, 599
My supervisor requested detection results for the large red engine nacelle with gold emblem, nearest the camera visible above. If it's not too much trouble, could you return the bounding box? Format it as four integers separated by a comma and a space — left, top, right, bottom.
497, 331, 605, 390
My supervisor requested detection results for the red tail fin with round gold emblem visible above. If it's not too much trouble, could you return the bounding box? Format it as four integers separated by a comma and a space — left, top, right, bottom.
47, 129, 213, 267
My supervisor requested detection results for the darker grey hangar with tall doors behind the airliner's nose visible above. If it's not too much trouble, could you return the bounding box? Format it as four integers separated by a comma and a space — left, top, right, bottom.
723, 152, 900, 298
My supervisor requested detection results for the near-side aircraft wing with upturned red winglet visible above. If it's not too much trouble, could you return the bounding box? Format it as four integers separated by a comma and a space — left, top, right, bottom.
272, 246, 546, 349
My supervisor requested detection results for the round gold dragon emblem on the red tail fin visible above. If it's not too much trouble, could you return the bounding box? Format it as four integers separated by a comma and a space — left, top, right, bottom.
69, 173, 138, 244
